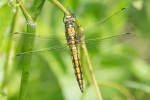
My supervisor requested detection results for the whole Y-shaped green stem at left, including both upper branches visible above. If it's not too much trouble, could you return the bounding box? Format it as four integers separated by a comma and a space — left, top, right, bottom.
17, 0, 45, 100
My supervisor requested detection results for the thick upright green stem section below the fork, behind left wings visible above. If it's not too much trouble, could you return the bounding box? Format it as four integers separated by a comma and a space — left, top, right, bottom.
19, 23, 36, 100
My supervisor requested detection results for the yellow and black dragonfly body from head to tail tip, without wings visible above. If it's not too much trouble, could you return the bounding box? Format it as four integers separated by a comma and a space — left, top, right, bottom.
64, 16, 83, 92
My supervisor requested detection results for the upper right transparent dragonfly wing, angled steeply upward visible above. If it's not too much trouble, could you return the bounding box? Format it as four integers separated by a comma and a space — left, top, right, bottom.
83, 8, 130, 39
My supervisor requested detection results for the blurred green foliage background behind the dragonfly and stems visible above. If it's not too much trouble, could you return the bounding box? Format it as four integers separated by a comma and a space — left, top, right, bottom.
0, 0, 150, 100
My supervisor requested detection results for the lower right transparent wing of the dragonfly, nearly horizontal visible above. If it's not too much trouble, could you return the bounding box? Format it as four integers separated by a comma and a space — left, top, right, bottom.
82, 33, 135, 51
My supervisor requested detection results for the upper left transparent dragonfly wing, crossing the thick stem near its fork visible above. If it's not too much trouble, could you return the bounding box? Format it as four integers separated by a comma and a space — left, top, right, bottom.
13, 32, 66, 50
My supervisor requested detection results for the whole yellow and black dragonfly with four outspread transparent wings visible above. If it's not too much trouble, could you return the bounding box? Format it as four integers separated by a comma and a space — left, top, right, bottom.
13, 8, 135, 93
